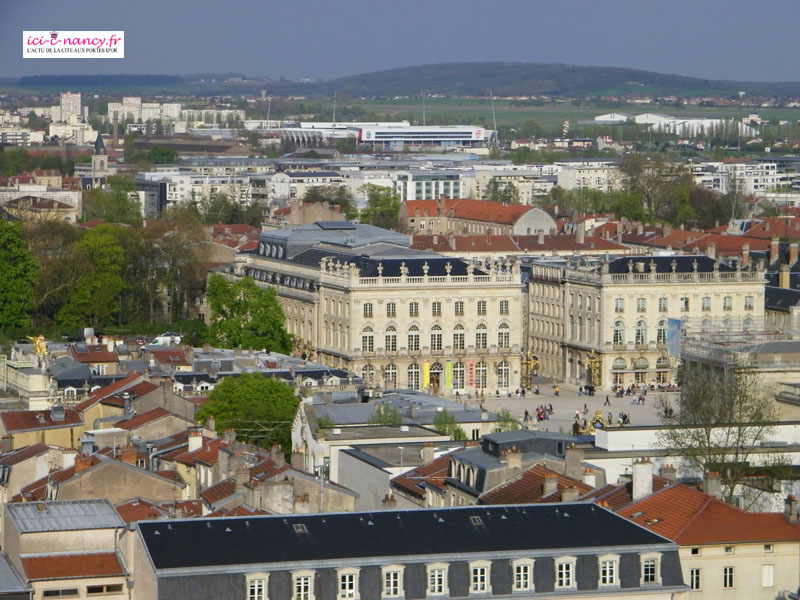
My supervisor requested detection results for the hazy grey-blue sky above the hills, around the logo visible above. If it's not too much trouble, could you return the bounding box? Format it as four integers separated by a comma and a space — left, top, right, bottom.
0, 0, 800, 81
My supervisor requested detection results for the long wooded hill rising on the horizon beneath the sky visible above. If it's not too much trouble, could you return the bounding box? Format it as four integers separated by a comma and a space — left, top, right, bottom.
313, 62, 800, 97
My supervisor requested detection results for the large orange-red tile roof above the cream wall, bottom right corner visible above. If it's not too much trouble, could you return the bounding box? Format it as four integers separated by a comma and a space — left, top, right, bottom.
619, 484, 800, 546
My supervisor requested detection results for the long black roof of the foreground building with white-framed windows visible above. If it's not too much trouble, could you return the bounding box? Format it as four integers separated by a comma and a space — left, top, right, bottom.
137, 503, 669, 570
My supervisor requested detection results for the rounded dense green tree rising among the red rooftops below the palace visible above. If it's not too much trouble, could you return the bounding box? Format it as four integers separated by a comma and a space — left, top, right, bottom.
197, 373, 300, 454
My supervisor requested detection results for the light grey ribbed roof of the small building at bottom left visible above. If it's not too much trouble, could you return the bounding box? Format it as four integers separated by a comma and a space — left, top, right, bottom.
6, 500, 122, 533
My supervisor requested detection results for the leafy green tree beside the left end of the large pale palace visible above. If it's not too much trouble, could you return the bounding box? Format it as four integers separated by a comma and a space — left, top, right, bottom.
206, 274, 292, 353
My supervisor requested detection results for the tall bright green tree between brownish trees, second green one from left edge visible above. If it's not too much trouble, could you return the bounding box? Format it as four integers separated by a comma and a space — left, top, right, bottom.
57, 225, 125, 327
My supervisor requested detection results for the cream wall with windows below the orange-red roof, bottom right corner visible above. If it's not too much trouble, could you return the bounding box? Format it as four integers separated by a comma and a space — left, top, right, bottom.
680, 540, 800, 600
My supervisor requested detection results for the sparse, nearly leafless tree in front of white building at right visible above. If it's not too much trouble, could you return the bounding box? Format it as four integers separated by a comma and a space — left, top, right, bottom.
656, 364, 784, 502
